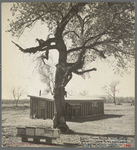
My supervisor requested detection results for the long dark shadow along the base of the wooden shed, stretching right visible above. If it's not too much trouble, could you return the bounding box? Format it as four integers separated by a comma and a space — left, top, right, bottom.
66, 114, 123, 123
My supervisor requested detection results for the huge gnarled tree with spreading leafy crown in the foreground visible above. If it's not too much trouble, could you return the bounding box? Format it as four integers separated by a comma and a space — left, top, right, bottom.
8, 2, 135, 131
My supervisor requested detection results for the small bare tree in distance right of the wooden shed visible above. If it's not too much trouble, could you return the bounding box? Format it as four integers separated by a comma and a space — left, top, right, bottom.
103, 81, 120, 105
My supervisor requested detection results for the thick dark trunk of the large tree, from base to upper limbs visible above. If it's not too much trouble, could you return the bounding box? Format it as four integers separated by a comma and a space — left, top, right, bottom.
53, 37, 69, 133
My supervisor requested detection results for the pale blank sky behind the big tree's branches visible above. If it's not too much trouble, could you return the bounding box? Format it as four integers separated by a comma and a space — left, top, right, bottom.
2, 3, 135, 99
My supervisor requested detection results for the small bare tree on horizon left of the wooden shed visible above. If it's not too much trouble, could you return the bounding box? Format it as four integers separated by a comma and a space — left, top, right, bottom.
11, 87, 25, 107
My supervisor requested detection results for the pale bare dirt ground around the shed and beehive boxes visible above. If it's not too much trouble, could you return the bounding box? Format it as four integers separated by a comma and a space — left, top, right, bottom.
2, 104, 135, 148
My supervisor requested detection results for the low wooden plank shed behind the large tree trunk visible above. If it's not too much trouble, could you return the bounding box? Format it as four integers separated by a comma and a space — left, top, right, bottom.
29, 95, 104, 119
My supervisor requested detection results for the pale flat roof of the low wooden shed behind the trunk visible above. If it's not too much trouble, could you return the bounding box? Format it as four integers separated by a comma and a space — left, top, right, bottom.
28, 95, 105, 102
